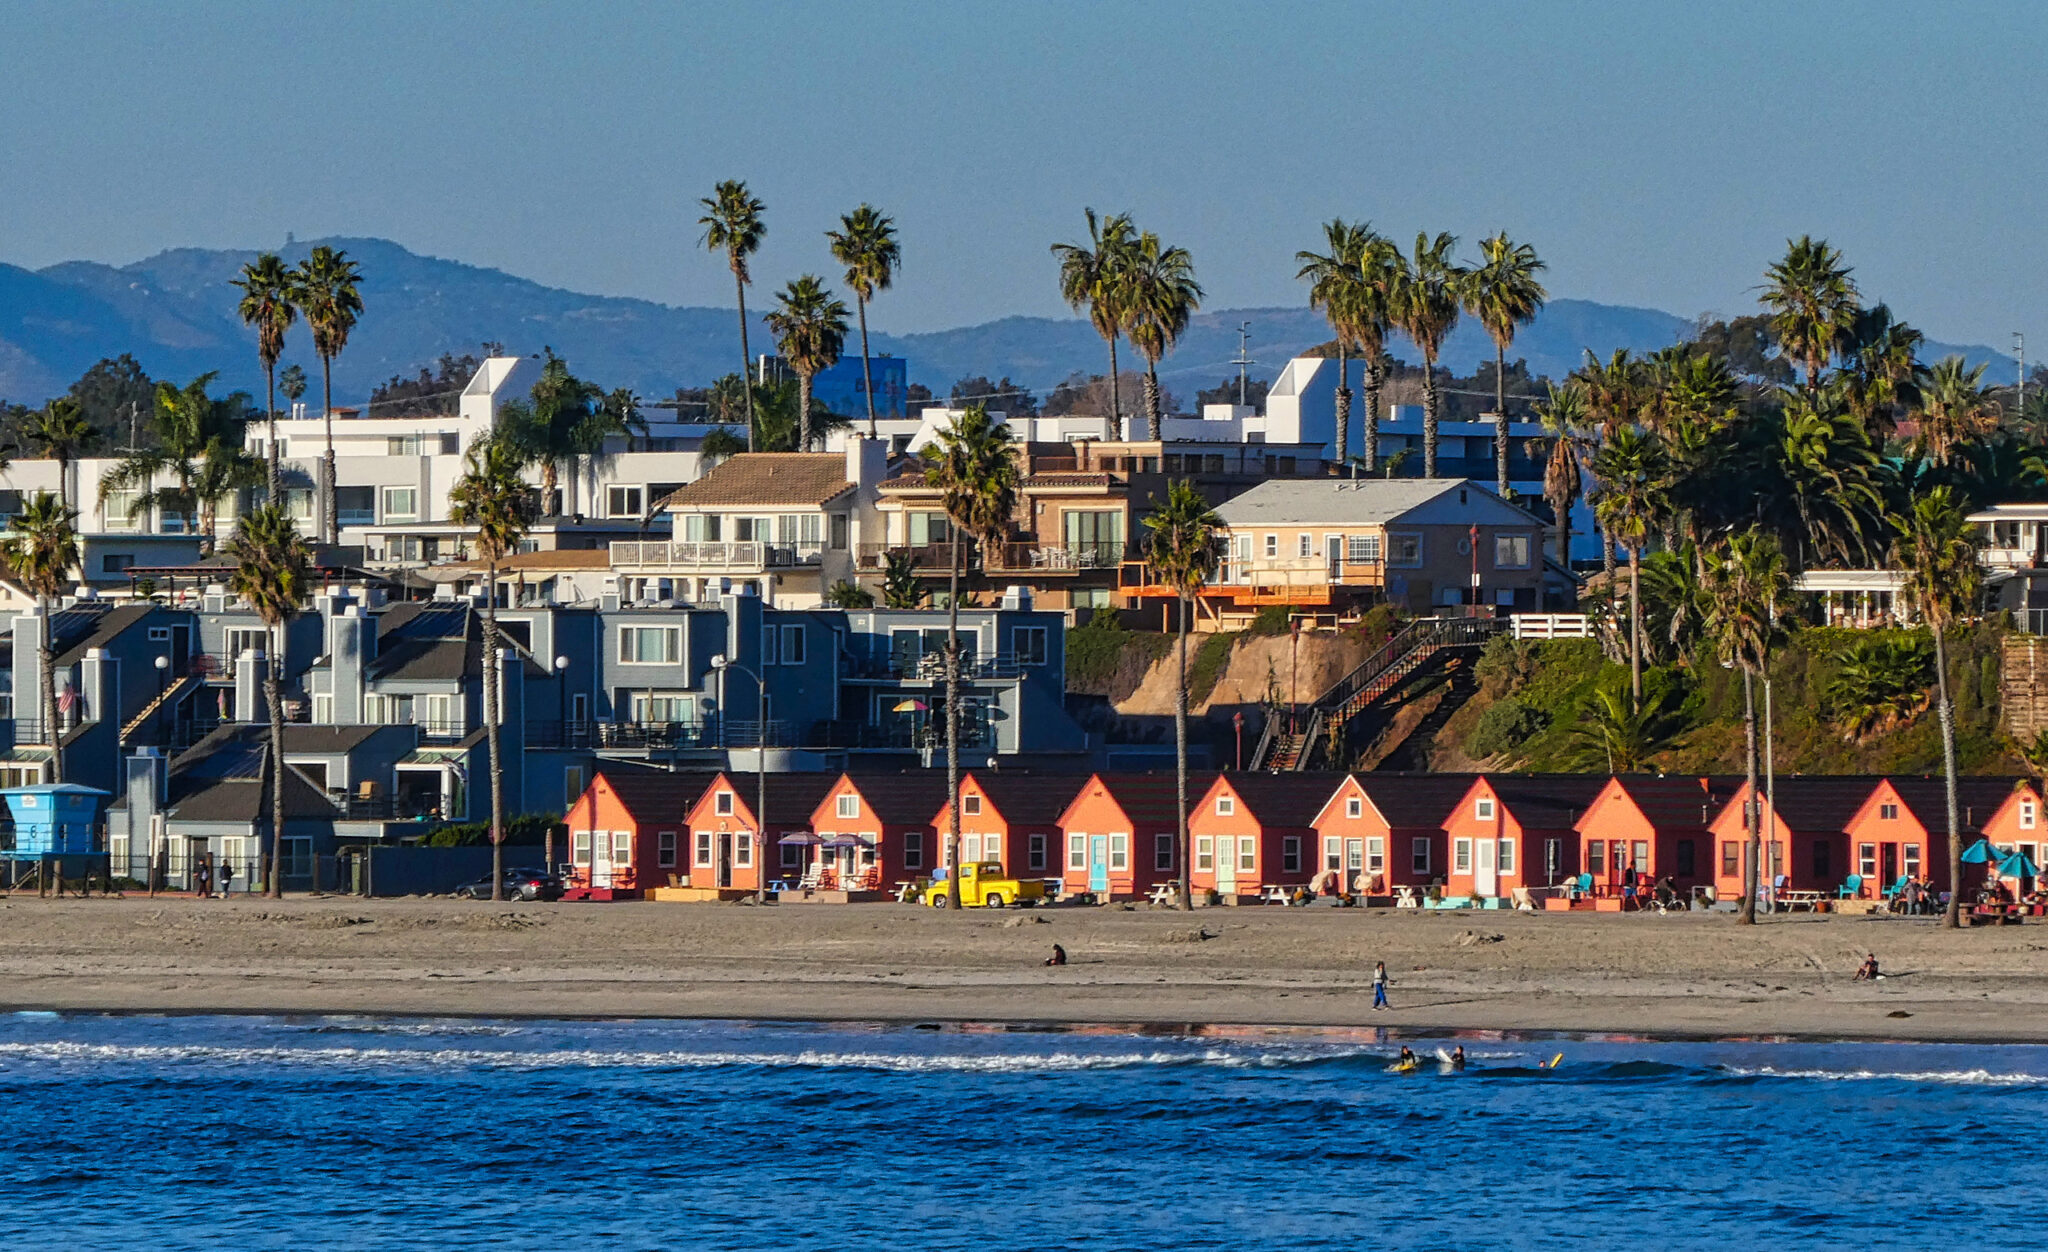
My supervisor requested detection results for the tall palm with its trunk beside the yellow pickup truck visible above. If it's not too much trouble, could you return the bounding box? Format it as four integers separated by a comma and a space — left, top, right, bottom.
924, 404, 1018, 908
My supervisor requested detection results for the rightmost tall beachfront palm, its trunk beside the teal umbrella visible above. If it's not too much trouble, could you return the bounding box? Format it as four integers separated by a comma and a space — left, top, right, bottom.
1892, 486, 1982, 926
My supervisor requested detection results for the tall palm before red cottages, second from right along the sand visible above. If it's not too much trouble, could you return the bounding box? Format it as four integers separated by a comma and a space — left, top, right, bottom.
1702, 527, 1792, 924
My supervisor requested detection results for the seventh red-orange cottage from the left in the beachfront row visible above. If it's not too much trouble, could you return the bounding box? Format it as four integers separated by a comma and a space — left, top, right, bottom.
1311, 775, 1473, 895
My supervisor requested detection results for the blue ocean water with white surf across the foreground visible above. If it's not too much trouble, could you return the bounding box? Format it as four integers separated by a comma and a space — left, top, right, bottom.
0, 1014, 2048, 1252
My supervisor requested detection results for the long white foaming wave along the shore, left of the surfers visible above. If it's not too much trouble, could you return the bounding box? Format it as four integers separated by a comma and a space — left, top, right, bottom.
0, 1041, 1384, 1074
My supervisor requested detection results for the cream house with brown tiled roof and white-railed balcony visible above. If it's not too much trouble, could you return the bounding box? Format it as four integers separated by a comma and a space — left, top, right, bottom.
610, 439, 889, 609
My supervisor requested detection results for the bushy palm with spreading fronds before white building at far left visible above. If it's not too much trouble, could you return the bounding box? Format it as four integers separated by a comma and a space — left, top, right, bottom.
100, 373, 264, 555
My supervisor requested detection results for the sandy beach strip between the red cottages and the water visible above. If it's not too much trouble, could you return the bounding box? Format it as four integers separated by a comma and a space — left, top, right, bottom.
0, 898, 2048, 1041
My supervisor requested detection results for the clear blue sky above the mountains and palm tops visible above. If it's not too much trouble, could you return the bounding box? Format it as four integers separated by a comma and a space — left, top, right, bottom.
0, 0, 2048, 350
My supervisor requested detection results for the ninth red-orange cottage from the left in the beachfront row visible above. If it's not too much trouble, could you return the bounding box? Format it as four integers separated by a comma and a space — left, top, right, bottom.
1559, 775, 1741, 898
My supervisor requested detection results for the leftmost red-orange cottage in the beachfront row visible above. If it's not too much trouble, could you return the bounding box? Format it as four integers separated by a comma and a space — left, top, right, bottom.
567, 764, 711, 900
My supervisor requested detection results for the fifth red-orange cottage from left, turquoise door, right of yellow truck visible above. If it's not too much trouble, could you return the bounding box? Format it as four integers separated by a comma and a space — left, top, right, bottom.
1059, 775, 1192, 900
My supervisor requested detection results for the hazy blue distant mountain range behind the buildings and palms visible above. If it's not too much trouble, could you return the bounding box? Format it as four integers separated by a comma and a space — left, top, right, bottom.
0, 238, 2003, 404
